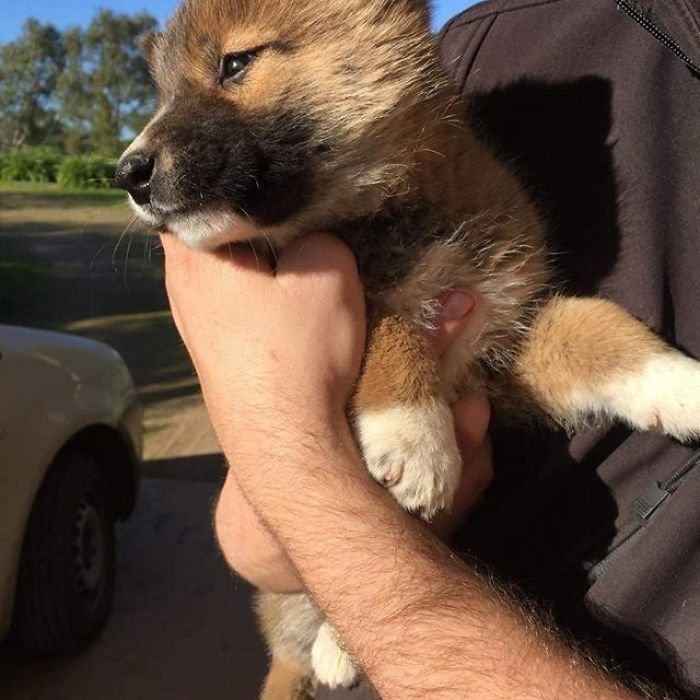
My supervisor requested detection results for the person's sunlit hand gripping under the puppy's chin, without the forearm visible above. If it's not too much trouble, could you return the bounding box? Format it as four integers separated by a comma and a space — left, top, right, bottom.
163, 236, 365, 460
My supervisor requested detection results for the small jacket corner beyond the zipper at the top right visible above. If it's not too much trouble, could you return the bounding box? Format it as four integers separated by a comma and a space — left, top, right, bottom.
615, 0, 700, 75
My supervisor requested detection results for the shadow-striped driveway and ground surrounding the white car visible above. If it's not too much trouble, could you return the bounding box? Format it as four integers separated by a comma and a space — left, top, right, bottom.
0, 185, 265, 700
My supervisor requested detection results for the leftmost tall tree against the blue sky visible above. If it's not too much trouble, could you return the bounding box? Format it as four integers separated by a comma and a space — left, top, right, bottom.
0, 19, 64, 148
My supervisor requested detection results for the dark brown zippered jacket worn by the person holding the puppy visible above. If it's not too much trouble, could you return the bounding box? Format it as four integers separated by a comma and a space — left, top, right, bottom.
318, 0, 700, 700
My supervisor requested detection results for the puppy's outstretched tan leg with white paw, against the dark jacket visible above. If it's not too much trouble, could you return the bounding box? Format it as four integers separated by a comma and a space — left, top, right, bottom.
516, 297, 700, 440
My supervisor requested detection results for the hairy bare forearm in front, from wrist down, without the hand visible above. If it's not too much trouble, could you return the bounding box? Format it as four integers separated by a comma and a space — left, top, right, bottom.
239, 426, 652, 700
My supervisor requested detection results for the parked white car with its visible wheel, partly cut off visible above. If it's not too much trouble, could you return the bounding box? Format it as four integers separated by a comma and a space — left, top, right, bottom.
0, 325, 143, 653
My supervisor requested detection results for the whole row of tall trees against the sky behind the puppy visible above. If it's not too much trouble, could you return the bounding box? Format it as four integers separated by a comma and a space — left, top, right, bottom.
0, 10, 158, 156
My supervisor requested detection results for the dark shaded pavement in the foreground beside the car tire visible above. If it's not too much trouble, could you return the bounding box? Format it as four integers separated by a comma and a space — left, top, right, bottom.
0, 478, 266, 700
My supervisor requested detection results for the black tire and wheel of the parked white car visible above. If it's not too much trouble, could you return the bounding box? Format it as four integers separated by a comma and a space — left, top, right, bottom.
14, 453, 115, 654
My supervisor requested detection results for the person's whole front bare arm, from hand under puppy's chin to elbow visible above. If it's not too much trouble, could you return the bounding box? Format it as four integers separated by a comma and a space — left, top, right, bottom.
165, 238, 668, 700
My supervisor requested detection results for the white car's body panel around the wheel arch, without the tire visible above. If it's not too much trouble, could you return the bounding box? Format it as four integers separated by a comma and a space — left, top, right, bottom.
0, 325, 142, 638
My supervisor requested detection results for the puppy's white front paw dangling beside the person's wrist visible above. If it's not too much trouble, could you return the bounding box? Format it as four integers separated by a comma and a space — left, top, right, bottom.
356, 402, 462, 520
